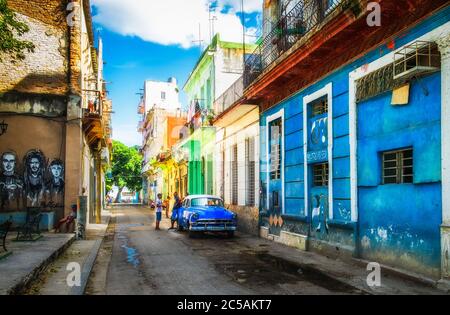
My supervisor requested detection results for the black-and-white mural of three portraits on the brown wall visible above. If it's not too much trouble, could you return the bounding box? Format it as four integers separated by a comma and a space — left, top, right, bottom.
0, 150, 65, 211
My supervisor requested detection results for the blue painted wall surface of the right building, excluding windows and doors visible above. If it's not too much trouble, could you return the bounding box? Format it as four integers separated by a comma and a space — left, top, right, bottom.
260, 8, 449, 276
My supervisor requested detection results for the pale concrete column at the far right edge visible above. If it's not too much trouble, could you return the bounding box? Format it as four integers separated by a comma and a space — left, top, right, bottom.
437, 34, 450, 280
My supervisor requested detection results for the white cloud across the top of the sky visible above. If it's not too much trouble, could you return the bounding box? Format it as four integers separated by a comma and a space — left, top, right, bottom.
92, 0, 262, 48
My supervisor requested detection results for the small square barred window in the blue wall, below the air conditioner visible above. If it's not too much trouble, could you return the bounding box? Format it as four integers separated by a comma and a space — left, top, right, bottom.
383, 149, 414, 185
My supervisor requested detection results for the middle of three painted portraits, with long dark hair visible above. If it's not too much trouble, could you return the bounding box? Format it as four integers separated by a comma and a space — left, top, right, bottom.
24, 150, 45, 207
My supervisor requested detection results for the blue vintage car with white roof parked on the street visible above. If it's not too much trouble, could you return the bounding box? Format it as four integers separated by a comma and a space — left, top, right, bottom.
178, 195, 237, 237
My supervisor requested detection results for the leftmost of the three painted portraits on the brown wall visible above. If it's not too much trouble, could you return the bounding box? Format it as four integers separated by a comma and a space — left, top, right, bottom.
0, 151, 24, 211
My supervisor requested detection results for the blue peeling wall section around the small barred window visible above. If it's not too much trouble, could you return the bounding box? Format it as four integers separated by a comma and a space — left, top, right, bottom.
358, 73, 442, 277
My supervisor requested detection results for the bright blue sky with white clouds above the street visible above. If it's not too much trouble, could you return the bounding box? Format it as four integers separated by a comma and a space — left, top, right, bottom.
91, 0, 263, 146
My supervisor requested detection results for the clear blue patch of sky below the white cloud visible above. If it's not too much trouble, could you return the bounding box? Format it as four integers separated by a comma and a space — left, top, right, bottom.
96, 29, 200, 145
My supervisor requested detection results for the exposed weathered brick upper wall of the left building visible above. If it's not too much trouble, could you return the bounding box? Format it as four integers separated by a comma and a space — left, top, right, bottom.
0, 0, 69, 96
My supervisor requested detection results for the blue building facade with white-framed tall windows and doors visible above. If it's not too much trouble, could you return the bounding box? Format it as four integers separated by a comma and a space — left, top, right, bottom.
260, 7, 450, 278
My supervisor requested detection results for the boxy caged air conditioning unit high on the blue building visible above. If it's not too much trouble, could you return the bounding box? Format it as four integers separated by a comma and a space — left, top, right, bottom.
394, 41, 441, 80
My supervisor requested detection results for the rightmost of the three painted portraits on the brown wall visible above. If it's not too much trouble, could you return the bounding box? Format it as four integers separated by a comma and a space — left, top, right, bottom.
45, 159, 65, 207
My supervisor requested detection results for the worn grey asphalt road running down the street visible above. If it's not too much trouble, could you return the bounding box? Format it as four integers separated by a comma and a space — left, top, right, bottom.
87, 207, 355, 295
